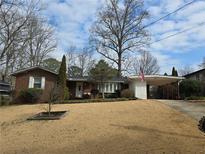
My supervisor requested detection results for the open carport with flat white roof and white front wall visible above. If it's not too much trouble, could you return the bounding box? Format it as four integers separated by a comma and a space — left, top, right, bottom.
129, 75, 184, 99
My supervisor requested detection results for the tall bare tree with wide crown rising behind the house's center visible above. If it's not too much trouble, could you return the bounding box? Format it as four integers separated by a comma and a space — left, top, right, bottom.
91, 0, 149, 76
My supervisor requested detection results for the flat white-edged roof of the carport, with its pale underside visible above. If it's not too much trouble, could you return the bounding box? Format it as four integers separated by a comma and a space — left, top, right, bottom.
129, 75, 185, 86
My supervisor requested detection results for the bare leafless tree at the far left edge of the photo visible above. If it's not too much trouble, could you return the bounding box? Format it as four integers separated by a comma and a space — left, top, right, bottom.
0, 0, 32, 76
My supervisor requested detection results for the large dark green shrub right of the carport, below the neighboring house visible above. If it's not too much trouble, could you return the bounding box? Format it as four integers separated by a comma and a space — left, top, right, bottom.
179, 79, 202, 98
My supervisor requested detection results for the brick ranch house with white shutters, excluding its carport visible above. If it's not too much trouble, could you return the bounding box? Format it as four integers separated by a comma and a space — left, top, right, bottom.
11, 66, 125, 102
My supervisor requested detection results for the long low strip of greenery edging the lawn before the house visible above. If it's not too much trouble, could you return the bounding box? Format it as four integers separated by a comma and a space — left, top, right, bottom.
55, 98, 137, 104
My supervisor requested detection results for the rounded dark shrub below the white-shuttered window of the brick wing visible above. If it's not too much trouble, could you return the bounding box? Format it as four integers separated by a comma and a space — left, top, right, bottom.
19, 88, 43, 103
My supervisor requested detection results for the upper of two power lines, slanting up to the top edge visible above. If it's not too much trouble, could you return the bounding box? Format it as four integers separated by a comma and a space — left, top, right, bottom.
142, 0, 197, 29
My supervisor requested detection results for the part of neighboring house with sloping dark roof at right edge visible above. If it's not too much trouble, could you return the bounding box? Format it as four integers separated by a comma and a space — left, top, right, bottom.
184, 68, 205, 82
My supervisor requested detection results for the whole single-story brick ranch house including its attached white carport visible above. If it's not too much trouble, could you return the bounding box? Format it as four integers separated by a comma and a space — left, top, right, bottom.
11, 66, 183, 102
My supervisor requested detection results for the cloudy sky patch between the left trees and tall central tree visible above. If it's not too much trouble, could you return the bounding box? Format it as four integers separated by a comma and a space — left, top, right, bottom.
41, 0, 103, 56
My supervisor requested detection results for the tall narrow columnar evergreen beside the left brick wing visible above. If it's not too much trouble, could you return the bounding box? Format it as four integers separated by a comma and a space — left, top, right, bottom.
57, 55, 68, 100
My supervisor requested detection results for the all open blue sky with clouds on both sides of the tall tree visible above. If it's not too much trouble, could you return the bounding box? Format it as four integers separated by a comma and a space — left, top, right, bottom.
43, 0, 205, 73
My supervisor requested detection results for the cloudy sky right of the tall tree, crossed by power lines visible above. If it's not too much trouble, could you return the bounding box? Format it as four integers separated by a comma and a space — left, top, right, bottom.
148, 0, 205, 73
